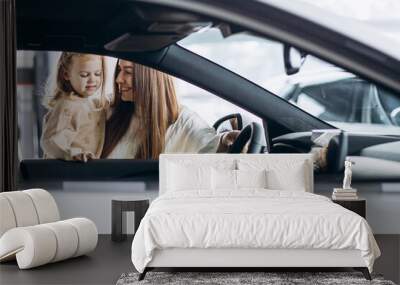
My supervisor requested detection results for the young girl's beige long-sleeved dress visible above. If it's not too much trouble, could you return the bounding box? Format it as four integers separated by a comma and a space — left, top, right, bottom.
41, 93, 106, 160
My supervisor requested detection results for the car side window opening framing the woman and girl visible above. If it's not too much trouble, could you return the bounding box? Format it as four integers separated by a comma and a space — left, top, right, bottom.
17, 51, 262, 161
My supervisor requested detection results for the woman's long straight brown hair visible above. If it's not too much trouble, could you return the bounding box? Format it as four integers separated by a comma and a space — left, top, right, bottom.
101, 63, 179, 159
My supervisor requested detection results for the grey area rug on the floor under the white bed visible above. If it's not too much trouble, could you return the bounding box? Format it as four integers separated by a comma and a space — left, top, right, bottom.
116, 272, 395, 285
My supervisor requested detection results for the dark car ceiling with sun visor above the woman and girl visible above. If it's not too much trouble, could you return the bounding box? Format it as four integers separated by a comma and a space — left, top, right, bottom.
17, 0, 212, 52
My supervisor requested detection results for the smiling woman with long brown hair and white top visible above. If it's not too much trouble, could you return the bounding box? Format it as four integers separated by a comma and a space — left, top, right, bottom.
102, 60, 231, 159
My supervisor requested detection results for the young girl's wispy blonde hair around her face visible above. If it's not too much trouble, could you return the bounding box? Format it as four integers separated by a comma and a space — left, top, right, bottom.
43, 52, 108, 109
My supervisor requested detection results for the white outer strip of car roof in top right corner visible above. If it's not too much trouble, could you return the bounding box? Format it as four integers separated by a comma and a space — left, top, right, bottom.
259, 0, 400, 60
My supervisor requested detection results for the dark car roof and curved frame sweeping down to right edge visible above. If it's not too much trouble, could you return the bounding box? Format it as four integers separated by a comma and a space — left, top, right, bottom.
16, 0, 400, 96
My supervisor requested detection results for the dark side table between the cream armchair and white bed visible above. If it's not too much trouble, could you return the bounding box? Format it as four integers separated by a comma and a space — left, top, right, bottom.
111, 198, 150, 241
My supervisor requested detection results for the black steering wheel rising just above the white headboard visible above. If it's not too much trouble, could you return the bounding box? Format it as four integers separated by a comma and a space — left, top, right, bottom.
228, 122, 265, 153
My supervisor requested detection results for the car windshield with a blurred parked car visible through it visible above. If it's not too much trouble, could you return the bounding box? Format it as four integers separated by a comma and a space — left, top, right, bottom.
178, 28, 400, 135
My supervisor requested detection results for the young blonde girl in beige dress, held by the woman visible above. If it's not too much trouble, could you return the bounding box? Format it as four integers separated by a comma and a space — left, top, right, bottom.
41, 52, 107, 162
